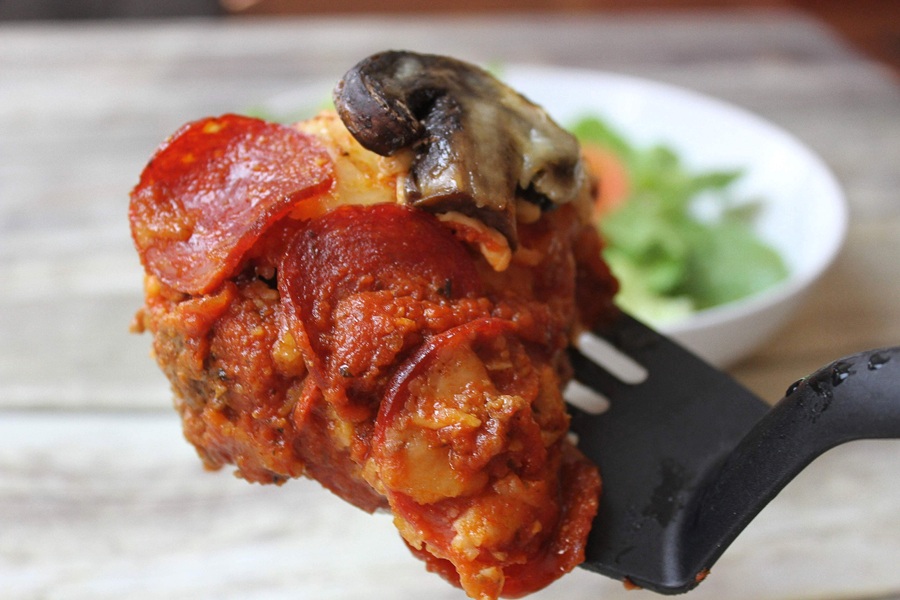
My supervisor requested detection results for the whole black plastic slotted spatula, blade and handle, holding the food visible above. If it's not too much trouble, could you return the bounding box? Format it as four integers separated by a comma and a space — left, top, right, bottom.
571, 314, 900, 594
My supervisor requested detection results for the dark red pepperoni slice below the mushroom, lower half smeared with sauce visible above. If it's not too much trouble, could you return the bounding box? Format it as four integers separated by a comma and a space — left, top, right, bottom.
278, 204, 481, 417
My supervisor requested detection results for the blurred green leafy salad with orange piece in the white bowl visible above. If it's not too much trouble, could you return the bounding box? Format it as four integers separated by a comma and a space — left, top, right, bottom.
571, 116, 788, 325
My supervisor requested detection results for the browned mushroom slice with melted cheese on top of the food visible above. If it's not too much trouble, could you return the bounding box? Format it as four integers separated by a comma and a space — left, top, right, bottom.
334, 51, 585, 248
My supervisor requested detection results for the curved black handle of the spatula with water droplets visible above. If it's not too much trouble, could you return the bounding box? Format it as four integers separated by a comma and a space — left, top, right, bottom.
684, 347, 900, 576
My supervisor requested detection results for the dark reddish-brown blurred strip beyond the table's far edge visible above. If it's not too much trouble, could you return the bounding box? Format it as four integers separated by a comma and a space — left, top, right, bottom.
0, 0, 900, 74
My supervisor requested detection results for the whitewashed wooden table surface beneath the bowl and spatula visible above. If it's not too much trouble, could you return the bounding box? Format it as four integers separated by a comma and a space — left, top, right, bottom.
0, 12, 900, 600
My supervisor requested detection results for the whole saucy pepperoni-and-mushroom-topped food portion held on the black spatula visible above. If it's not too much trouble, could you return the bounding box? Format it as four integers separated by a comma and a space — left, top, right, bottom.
129, 52, 616, 599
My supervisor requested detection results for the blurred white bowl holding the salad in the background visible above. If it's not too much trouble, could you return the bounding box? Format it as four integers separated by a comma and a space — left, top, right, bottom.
503, 66, 848, 367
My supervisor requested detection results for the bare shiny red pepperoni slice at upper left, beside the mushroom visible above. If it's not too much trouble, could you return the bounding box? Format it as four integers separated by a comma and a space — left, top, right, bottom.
129, 114, 332, 294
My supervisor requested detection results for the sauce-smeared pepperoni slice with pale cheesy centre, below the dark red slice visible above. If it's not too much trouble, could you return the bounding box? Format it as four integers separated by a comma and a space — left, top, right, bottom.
372, 317, 532, 504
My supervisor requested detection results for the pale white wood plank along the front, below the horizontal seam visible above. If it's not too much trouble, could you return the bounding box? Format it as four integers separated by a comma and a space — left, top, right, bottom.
0, 413, 900, 600
